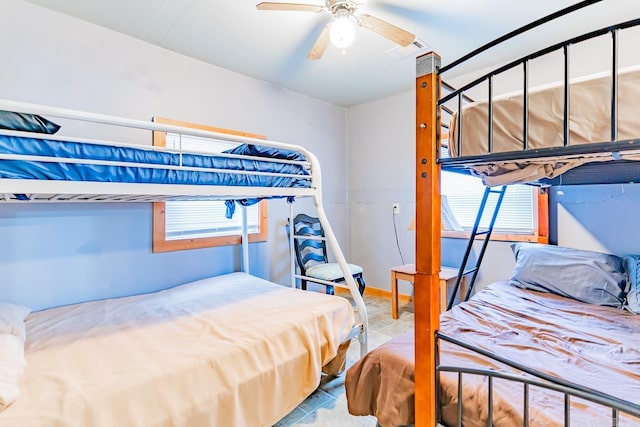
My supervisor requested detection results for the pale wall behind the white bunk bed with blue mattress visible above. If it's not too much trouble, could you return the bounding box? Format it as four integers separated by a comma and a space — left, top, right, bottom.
0, 0, 348, 308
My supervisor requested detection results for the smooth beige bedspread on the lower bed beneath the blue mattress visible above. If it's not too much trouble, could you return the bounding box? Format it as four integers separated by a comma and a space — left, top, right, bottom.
0, 273, 354, 427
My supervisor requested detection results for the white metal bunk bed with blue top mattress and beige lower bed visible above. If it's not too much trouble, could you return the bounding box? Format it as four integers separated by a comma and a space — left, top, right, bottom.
0, 100, 367, 427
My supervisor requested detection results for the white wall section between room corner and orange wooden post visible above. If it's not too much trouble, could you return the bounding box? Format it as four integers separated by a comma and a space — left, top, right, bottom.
348, 93, 415, 289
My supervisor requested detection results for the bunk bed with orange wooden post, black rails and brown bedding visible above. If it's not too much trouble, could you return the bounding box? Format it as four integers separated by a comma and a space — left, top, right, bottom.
345, 0, 640, 427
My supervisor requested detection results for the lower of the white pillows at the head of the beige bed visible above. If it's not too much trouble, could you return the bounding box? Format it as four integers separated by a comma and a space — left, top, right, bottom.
0, 334, 27, 411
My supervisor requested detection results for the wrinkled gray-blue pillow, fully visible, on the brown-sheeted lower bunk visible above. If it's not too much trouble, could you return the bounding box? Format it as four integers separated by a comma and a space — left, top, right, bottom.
511, 243, 626, 308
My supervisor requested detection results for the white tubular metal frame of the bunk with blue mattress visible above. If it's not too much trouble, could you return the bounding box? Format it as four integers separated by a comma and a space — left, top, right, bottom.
0, 99, 368, 355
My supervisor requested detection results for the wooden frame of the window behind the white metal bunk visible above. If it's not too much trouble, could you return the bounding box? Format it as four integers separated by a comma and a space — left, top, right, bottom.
153, 117, 268, 253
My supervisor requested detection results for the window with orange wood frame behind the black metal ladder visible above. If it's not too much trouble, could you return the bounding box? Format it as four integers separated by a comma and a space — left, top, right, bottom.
441, 171, 549, 242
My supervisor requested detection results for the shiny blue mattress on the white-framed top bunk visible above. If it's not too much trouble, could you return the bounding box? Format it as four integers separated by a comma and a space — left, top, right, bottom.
0, 135, 311, 188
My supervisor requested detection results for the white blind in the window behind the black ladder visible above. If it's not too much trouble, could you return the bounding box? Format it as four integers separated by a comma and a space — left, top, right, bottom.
441, 171, 537, 235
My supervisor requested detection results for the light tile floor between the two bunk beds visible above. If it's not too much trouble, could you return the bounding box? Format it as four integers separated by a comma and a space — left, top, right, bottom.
274, 294, 413, 427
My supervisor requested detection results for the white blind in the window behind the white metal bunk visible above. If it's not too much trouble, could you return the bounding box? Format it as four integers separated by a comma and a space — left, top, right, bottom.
165, 133, 260, 240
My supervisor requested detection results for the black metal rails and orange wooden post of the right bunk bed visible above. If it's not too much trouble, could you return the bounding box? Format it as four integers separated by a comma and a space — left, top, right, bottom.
414, 0, 640, 427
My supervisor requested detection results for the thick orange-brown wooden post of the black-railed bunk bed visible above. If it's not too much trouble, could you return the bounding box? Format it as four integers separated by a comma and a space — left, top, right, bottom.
414, 52, 441, 427
